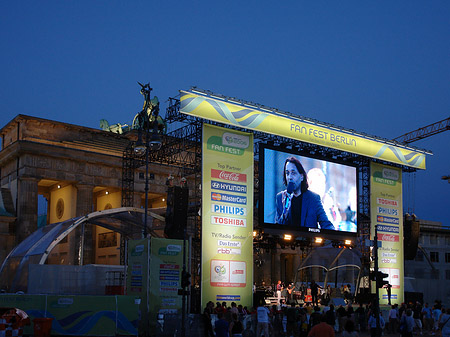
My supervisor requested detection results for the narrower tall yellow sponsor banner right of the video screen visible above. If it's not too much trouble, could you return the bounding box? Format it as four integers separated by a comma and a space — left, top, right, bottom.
370, 163, 404, 304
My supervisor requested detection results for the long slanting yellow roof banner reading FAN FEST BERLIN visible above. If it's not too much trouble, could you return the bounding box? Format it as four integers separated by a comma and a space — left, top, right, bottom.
180, 91, 425, 169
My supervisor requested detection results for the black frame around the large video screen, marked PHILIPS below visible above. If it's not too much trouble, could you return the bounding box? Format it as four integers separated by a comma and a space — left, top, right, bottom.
258, 143, 361, 240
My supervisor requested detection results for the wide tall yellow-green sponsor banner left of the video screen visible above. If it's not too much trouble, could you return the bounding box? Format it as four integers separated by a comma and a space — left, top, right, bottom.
201, 124, 254, 307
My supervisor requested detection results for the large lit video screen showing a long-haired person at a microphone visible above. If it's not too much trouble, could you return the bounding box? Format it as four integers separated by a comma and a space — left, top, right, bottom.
259, 145, 358, 236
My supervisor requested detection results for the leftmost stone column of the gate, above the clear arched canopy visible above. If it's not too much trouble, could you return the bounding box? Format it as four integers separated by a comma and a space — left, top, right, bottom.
15, 177, 38, 244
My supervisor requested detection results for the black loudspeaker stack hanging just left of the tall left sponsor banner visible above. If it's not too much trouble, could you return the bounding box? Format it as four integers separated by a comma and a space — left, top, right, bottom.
164, 186, 189, 239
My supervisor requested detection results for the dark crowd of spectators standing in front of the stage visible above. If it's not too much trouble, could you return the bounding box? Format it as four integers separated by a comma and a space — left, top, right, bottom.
203, 301, 450, 337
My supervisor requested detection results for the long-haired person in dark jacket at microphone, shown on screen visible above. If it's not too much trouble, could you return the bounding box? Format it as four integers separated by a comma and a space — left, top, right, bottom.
275, 157, 335, 230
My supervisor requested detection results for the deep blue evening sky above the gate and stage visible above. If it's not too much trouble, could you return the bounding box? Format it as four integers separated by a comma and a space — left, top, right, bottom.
0, 0, 450, 225
